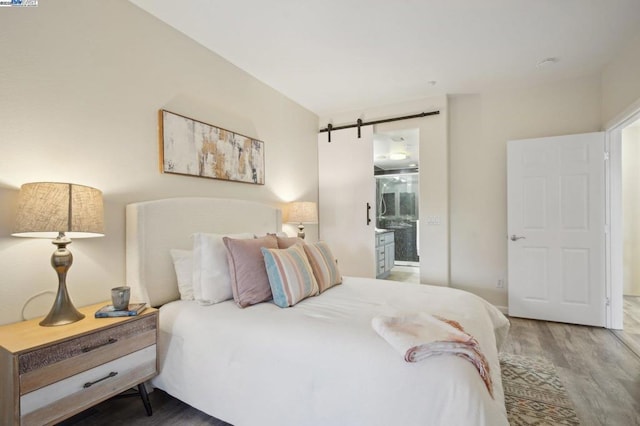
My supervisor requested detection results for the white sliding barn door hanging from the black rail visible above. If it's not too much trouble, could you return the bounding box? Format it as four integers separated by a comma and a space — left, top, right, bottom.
318, 126, 376, 277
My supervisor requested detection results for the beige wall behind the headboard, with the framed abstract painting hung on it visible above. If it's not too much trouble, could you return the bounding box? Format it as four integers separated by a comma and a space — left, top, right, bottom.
0, 0, 318, 323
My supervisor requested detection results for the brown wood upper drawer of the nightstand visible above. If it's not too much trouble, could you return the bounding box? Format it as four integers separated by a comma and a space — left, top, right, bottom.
18, 315, 156, 395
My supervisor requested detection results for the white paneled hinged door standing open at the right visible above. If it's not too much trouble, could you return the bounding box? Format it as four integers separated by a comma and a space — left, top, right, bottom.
507, 133, 606, 326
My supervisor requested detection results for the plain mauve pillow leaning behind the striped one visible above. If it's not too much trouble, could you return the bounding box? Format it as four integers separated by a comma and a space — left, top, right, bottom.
222, 235, 278, 308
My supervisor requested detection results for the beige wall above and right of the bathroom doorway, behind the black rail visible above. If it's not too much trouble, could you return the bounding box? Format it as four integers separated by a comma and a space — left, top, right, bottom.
320, 96, 449, 285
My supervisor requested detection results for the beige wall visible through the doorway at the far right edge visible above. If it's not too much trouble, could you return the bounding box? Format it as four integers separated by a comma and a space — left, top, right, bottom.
622, 126, 640, 296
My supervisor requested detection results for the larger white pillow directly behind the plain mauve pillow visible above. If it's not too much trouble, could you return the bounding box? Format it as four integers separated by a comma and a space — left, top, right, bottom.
192, 232, 253, 305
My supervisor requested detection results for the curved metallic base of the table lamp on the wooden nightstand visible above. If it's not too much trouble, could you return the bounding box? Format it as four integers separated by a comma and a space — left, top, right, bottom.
40, 232, 84, 327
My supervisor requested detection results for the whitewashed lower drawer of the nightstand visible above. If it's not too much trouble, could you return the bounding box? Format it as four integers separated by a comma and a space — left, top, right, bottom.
20, 345, 156, 425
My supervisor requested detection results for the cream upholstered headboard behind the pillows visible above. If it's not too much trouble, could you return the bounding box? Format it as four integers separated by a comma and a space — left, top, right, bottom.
126, 198, 282, 306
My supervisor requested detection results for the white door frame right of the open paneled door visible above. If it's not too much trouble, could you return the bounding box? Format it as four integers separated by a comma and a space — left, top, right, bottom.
605, 99, 640, 330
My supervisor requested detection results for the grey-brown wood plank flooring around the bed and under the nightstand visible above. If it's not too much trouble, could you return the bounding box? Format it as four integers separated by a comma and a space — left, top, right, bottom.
64, 297, 640, 426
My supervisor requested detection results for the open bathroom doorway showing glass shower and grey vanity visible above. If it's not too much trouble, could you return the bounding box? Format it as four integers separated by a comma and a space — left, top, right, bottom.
373, 129, 420, 283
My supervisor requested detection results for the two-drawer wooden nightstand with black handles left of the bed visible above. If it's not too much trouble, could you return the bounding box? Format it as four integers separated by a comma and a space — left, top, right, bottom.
0, 302, 158, 426
